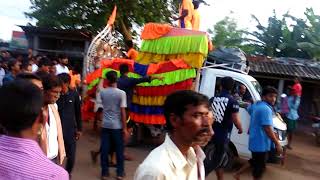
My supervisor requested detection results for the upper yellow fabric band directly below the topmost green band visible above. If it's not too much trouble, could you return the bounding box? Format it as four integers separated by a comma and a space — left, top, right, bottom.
137, 52, 205, 68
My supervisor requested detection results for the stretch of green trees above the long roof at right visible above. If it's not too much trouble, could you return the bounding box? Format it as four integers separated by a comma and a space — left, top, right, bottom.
208, 8, 320, 59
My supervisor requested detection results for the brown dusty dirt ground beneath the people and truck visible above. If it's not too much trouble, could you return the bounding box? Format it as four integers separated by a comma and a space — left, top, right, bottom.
73, 123, 320, 180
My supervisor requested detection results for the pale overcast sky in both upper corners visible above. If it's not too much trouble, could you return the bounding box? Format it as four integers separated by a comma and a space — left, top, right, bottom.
0, 0, 320, 40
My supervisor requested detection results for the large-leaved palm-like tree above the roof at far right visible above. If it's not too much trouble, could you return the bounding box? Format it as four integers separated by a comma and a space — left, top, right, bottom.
246, 12, 310, 58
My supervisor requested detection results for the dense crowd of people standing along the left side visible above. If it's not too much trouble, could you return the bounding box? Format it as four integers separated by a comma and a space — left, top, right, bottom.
0, 50, 82, 179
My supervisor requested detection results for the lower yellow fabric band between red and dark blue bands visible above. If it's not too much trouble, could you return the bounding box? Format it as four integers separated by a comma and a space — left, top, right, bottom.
132, 95, 166, 106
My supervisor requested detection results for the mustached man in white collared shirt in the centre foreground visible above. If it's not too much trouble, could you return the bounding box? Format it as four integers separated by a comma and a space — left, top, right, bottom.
134, 90, 213, 180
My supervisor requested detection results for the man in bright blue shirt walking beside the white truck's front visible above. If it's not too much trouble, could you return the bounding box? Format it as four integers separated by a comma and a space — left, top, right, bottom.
248, 87, 282, 179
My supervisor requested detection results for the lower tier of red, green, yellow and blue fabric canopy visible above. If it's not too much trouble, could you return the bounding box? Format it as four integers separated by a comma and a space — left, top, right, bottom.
86, 59, 196, 125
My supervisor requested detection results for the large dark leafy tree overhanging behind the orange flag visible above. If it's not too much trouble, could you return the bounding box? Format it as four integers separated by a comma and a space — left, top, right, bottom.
25, 0, 179, 40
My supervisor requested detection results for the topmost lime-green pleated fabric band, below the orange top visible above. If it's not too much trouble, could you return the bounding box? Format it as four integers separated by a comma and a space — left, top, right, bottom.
140, 35, 208, 56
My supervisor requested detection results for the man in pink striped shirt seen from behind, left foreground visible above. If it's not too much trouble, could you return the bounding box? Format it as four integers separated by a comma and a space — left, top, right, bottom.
0, 79, 69, 180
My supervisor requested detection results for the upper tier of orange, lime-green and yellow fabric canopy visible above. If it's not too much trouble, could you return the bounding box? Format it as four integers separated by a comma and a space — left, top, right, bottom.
137, 24, 212, 68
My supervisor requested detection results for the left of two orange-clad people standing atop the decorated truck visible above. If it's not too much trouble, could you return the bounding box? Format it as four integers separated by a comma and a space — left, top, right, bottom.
177, 0, 194, 29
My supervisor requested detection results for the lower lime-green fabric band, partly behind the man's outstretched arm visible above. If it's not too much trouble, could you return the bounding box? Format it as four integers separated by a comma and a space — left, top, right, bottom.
88, 68, 197, 90
